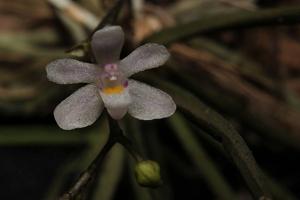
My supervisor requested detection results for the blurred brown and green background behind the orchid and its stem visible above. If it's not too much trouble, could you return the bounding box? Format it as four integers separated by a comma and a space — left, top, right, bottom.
0, 0, 300, 200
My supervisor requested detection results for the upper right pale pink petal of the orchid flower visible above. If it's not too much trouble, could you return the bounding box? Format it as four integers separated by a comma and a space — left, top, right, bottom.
120, 43, 170, 77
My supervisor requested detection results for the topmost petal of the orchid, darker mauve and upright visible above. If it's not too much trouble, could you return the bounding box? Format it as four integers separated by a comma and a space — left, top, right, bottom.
91, 26, 124, 65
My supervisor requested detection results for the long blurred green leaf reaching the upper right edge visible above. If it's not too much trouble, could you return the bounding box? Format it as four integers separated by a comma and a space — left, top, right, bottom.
146, 6, 300, 44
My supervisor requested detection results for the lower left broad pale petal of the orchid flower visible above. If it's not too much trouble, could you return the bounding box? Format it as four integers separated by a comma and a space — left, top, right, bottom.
54, 84, 103, 130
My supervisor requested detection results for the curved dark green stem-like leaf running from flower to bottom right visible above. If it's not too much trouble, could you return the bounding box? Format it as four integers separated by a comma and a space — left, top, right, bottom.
145, 77, 270, 199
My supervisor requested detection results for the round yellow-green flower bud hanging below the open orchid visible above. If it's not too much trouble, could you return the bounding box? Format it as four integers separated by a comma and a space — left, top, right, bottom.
135, 160, 162, 188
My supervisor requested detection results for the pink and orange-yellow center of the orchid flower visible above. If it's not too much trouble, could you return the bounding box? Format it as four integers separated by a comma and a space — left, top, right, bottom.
100, 64, 128, 94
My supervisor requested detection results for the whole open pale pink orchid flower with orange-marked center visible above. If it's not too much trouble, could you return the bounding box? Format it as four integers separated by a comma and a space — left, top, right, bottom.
46, 26, 176, 130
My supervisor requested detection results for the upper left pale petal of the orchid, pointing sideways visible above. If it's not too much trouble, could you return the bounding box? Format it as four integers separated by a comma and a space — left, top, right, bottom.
46, 58, 100, 84
